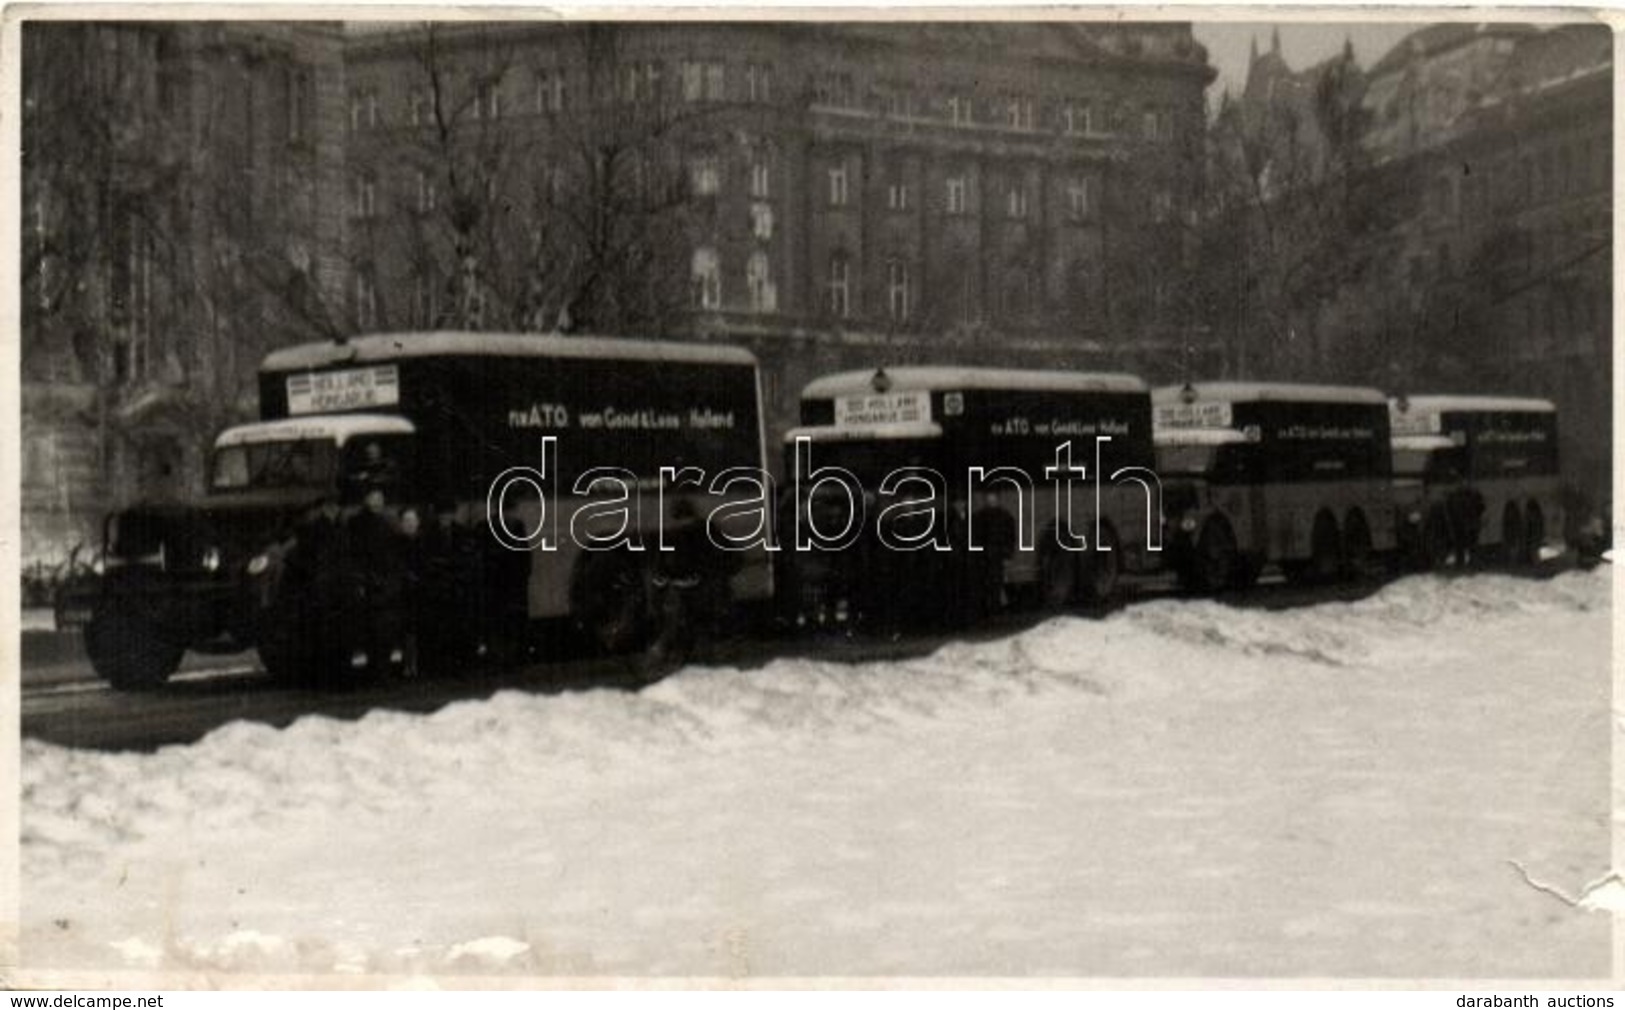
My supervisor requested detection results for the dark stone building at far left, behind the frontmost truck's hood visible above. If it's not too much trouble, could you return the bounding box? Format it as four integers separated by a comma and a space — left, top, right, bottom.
21, 21, 346, 563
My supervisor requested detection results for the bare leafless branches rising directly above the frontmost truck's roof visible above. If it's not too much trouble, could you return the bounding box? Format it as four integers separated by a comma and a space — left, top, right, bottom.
354, 24, 720, 335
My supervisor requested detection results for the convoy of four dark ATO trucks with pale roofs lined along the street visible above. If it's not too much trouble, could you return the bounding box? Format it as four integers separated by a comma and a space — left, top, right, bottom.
59, 331, 1562, 690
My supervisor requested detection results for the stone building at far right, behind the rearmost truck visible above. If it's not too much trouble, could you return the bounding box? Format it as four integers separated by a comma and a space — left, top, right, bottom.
1246, 23, 1614, 505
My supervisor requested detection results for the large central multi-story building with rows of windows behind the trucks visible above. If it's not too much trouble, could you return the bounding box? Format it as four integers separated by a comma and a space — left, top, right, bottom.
348, 23, 1214, 425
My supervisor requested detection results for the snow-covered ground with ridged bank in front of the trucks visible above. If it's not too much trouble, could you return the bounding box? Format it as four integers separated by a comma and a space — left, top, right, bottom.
21, 570, 1610, 986
